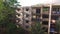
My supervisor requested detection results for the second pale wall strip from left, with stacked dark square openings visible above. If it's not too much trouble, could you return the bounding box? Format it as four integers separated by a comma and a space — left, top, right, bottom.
23, 7, 32, 29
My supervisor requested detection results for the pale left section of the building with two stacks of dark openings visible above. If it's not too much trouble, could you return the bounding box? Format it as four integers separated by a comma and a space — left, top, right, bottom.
16, 7, 32, 30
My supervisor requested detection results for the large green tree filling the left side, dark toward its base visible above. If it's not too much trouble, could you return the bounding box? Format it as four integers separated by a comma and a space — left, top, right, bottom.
0, 0, 18, 34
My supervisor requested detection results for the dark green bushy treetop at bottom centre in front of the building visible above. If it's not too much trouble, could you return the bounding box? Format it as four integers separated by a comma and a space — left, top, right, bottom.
32, 22, 45, 34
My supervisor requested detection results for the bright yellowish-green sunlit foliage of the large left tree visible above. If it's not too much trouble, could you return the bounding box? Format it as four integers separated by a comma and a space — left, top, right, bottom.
0, 0, 15, 22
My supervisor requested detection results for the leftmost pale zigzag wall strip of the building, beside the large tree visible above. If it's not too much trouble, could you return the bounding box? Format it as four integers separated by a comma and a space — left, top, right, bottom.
16, 8, 23, 25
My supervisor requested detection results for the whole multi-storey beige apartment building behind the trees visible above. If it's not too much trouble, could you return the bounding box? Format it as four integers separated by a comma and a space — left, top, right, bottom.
16, 4, 60, 34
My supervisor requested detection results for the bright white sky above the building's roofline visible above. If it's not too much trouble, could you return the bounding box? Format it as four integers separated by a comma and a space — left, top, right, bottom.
18, 0, 60, 6
